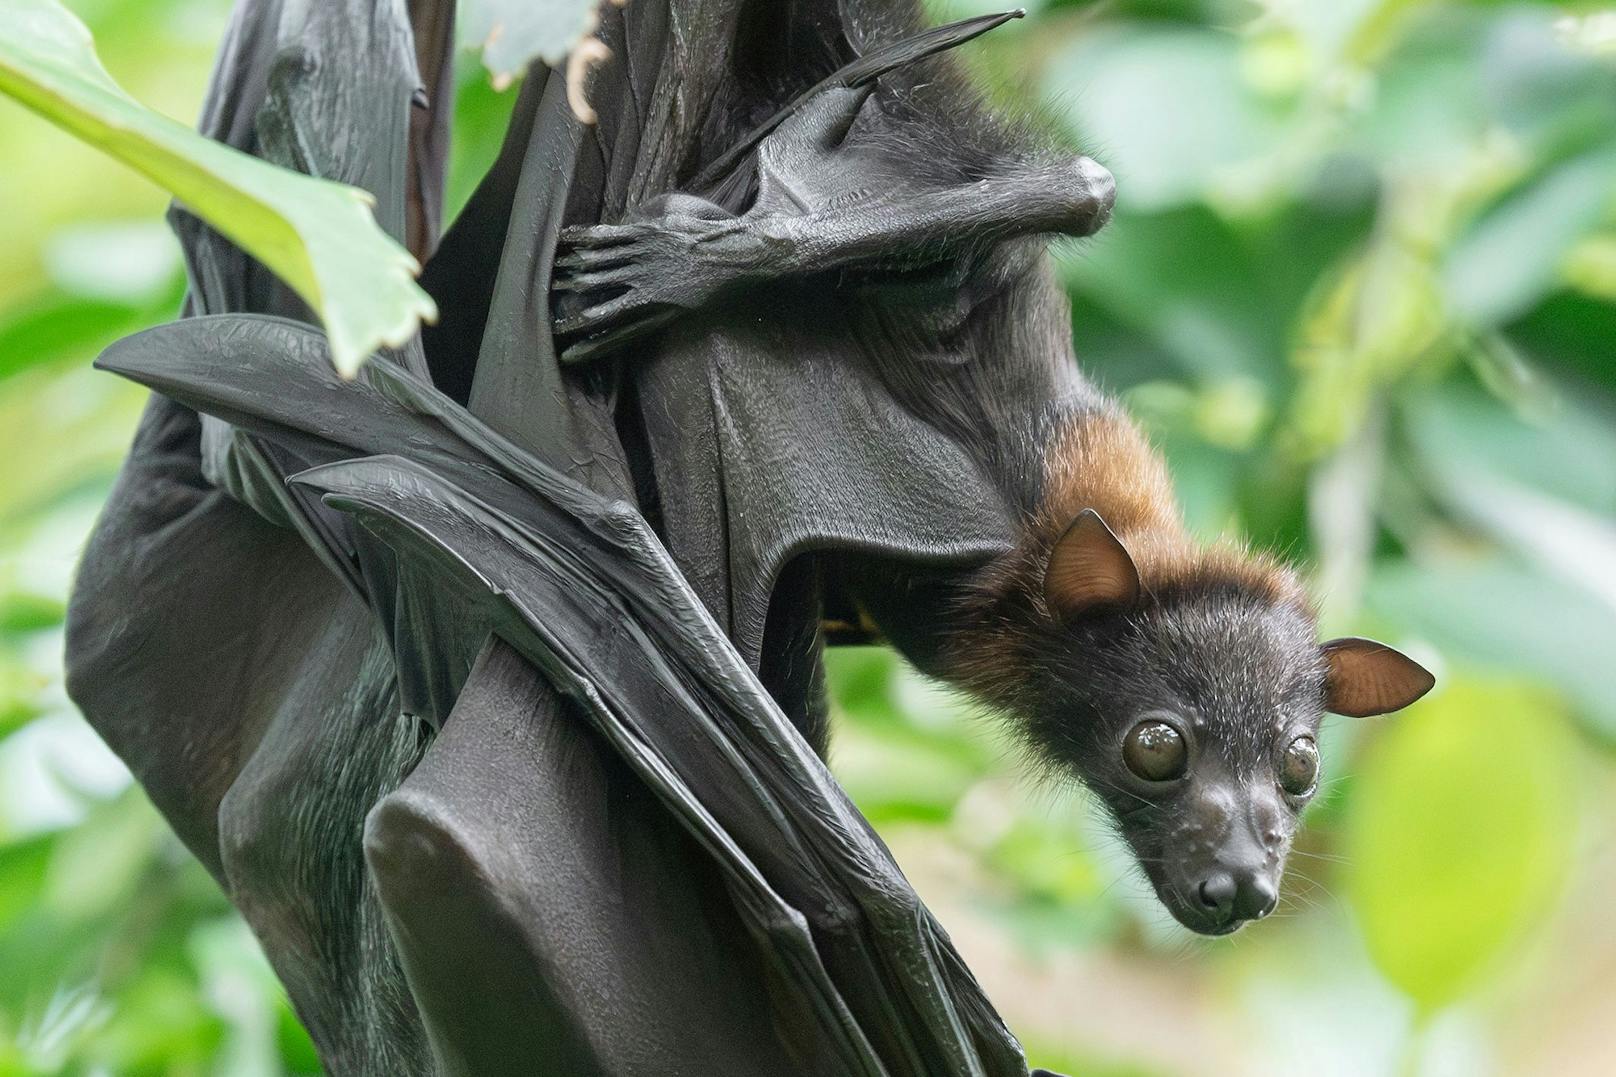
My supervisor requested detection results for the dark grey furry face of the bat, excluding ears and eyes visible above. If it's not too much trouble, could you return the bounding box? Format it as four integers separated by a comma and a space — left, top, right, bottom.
1031, 590, 1325, 935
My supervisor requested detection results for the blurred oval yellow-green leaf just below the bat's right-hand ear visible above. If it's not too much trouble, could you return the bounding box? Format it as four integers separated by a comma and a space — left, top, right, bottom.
1346, 681, 1577, 1012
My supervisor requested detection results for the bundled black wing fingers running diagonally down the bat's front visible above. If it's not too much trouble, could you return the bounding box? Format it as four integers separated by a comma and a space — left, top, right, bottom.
99, 315, 1025, 1074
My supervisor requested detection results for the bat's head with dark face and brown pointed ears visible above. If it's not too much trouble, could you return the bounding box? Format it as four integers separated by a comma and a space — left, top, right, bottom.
1021, 509, 1433, 935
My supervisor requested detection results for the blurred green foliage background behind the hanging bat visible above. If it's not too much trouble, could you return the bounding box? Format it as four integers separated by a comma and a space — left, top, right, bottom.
0, 0, 1616, 1075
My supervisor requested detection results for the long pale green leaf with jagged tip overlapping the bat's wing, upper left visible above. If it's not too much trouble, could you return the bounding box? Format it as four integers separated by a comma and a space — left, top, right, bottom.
0, 0, 436, 375
